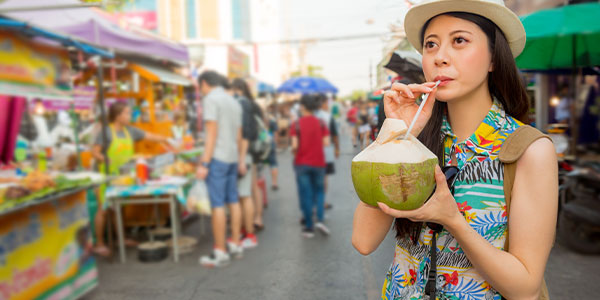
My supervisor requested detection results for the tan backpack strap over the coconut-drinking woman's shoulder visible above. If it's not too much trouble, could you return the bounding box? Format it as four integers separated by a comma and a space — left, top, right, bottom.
498, 125, 551, 300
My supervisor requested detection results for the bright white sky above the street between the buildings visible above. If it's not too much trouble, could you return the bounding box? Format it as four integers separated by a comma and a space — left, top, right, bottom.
282, 0, 407, 96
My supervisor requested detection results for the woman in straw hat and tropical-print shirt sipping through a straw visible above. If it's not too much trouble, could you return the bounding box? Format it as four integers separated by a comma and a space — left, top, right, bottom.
352, 0, 558, 299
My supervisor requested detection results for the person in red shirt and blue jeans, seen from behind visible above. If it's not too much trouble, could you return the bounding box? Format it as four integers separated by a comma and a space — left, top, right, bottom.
290, 95, 330, 238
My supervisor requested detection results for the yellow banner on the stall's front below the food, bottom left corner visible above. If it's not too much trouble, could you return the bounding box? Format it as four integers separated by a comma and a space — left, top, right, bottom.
0, 191, 98, 300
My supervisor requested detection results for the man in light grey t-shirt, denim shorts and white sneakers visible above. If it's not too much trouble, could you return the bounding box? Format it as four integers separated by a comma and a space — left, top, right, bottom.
197, 71, 247, 267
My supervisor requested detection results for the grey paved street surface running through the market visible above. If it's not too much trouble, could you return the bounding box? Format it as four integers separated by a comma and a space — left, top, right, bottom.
86, 134, 600, 300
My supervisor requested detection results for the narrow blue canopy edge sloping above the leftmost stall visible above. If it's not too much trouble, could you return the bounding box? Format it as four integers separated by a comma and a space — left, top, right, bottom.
0, 16, 114, 58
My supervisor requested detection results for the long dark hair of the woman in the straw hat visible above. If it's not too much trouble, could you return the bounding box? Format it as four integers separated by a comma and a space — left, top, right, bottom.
394, 12, 529, 243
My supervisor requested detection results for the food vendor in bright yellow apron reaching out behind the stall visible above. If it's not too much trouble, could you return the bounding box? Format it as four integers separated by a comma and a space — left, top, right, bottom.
92, 102, 168, 256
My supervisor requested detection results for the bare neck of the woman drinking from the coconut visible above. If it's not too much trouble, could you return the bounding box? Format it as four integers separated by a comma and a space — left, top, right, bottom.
448, 84, 492, 142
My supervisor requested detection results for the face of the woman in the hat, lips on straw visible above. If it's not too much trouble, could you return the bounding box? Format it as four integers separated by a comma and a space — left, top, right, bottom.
423, 15, 492, 102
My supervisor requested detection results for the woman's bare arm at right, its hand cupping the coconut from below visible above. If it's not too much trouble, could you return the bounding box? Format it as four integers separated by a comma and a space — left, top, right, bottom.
379, 139, 558, 299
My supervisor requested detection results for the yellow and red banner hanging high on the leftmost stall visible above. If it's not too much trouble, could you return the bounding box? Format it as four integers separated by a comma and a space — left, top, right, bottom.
0, 31, 71, 90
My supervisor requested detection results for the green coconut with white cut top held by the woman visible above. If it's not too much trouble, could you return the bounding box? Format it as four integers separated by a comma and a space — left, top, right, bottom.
352, 119, 438, 210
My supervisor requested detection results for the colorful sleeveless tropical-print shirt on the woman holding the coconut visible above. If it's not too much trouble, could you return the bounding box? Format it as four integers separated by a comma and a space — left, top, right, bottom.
382, 100, 523, 300
